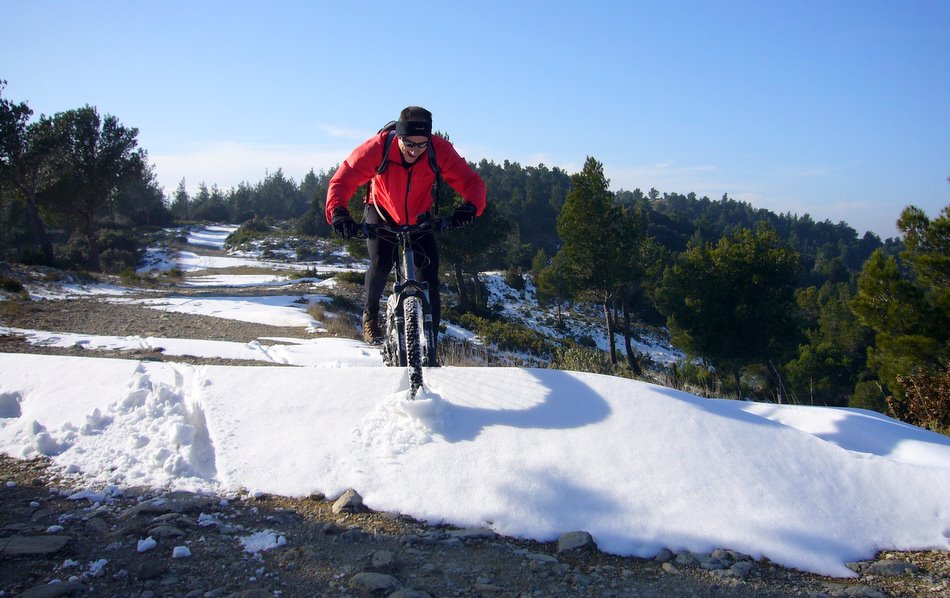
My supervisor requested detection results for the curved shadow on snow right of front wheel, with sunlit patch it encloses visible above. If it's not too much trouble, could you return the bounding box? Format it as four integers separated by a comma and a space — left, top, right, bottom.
430, 368, 611, 442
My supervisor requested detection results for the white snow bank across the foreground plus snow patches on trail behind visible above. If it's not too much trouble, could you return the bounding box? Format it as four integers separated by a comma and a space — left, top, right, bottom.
0, 224, 950, 576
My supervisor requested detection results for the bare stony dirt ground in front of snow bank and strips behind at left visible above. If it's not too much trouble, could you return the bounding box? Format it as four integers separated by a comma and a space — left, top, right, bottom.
0, 274, 950, 597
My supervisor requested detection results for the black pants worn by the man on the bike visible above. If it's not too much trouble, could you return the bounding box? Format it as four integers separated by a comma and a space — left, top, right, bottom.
363, 204, 442, 337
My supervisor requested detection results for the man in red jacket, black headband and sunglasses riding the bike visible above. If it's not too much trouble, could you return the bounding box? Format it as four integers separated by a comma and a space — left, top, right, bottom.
326, 106, 485, 344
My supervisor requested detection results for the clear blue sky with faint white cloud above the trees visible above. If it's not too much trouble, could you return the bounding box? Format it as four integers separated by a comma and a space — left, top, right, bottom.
0, 0, 950, 237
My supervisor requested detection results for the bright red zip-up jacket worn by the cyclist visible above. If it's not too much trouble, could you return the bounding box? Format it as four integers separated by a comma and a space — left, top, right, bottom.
326, 132, 485, 224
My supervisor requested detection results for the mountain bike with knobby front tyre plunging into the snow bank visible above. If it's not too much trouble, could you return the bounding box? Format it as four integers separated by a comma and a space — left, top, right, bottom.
356, 218, 450, 399
